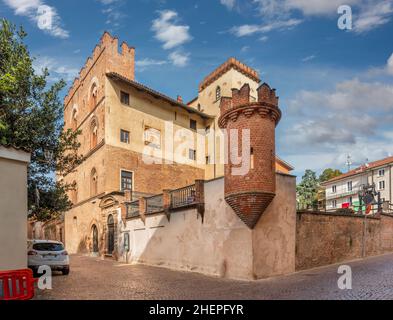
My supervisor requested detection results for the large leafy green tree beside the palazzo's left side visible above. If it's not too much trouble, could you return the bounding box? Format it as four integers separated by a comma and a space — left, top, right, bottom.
0, 19, 82, 220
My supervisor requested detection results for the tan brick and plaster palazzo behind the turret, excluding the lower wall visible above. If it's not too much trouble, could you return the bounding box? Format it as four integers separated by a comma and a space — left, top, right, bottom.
64, 32, 292, 256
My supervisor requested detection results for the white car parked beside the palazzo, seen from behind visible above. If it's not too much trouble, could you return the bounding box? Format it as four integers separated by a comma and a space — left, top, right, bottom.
27, 240, 70, 275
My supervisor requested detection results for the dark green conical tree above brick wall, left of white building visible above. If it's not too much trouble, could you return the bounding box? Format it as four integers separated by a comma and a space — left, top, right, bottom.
296, 169, 319, 209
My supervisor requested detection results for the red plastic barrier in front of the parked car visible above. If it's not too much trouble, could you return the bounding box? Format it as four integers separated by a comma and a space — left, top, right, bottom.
0, 269, 35, 300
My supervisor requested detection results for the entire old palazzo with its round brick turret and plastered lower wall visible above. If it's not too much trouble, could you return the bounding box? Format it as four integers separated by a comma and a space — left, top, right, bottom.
64, 33, 295, 277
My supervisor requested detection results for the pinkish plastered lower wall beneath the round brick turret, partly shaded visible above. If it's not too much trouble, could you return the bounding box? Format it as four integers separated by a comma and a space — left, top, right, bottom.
118, 175, 296, 280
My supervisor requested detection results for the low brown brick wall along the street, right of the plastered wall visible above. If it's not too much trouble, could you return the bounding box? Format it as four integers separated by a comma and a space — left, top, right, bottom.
296, 212, 393, 270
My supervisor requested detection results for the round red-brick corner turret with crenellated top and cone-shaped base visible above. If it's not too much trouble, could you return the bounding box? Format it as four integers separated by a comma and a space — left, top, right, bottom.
218, 83, 281, 229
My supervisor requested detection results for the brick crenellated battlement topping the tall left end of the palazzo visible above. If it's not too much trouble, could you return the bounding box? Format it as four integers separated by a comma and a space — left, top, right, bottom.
64, 31, 135, 106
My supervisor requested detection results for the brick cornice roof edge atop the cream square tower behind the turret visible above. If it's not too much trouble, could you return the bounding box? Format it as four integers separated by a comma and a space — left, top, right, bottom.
199, 58, 261, 91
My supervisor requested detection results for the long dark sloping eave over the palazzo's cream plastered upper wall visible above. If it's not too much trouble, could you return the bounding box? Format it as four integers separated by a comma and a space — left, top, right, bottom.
106, 72, 213, 119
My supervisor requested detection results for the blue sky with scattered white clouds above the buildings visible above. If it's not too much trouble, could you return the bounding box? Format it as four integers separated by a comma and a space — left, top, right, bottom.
0, 0, 393, 175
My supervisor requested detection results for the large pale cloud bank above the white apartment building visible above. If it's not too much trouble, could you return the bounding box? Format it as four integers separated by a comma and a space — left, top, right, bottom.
279, 78, 393, 175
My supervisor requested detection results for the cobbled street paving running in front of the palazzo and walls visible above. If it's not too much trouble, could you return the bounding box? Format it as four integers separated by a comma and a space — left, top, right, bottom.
36, 254, 393, 300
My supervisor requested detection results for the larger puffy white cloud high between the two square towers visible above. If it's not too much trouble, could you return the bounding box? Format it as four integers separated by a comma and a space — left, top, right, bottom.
152, 10, 192, 49
